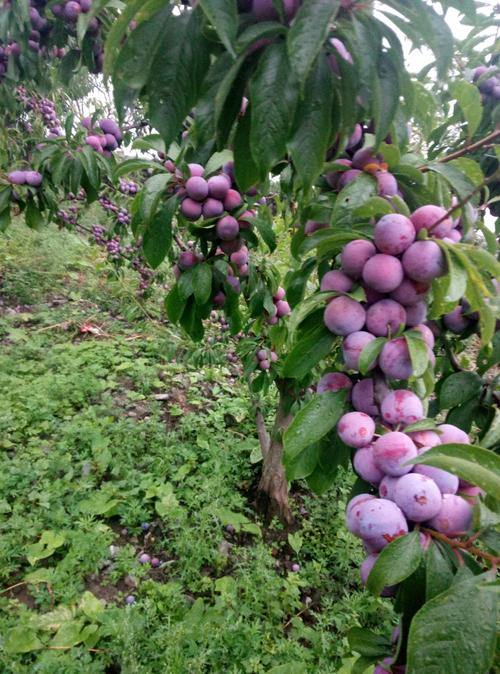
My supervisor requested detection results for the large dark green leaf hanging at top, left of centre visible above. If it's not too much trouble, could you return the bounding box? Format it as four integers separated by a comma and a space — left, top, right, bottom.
143, 8, 209, 146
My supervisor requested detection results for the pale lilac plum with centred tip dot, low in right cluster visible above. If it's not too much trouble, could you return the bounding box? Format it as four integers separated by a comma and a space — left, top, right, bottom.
394, 473, 442, 522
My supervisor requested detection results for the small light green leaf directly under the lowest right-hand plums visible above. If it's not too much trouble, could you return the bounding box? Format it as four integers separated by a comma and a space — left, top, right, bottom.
366, 531, 423, 595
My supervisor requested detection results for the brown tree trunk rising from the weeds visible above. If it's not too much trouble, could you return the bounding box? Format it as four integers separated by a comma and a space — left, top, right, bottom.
256, 382, 293, 524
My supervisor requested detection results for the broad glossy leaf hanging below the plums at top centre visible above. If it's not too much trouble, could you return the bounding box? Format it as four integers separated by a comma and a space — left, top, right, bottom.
250, 42, 298, 180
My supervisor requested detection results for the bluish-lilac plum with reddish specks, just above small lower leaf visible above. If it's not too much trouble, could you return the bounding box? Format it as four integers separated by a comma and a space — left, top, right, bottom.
359, 498, 408, 552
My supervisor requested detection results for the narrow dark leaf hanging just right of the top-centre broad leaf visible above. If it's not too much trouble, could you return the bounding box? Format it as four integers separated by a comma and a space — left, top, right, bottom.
288, 55, 333, 191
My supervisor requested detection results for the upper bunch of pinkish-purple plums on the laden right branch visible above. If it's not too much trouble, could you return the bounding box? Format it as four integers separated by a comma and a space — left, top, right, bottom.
320, 205, 464, 379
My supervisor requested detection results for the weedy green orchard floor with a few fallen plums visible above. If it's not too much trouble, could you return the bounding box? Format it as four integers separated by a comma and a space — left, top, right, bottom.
0, 226, 392, 674
